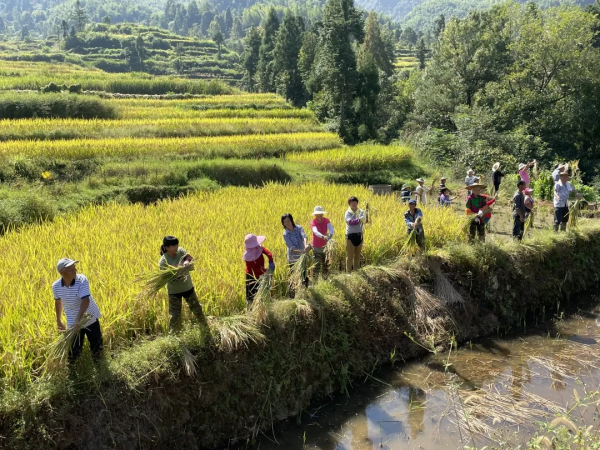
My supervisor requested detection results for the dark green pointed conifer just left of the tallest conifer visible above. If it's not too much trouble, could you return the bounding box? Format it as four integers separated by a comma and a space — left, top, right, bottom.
273, 10, 306, 106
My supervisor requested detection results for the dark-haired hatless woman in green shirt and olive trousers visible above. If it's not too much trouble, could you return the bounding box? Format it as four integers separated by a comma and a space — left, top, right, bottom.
158, 236, 206, 333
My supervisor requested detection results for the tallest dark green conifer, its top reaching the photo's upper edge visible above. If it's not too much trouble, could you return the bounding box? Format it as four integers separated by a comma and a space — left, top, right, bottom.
313, 0, 364, 142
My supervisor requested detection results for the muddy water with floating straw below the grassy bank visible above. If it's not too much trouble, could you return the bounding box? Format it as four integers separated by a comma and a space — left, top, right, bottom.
253, 296, 600, 450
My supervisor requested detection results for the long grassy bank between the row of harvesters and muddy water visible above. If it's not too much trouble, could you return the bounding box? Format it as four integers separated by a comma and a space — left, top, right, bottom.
0, 223, 600, 449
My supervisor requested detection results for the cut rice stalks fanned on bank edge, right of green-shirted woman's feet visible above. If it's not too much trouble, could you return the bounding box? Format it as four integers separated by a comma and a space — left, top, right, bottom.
209, 314, 265, 353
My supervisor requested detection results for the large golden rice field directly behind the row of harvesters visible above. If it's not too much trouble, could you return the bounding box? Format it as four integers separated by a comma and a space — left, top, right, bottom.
0, 183, 465, 386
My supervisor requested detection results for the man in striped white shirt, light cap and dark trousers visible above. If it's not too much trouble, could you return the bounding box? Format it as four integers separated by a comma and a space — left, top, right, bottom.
52, 258, 103, 363
